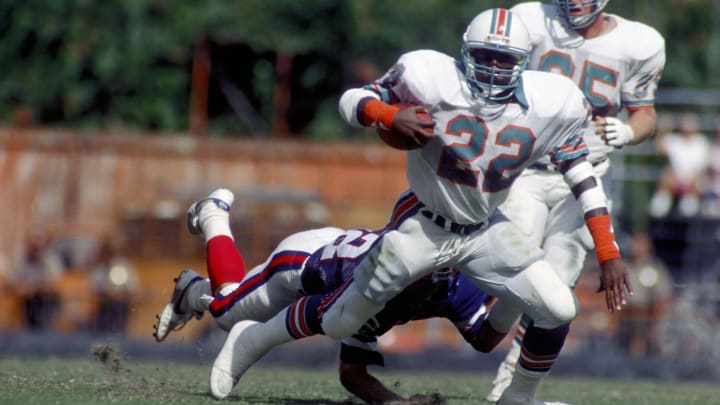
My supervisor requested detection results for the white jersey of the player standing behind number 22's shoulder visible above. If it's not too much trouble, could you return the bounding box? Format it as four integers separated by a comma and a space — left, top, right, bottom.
511, 2, 665, 162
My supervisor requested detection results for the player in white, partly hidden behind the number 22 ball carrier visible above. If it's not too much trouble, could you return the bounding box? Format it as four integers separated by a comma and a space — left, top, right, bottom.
486, 0, 665, 402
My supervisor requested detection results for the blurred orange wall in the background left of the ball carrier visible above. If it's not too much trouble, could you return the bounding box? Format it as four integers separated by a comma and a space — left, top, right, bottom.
0, 128, 414, 337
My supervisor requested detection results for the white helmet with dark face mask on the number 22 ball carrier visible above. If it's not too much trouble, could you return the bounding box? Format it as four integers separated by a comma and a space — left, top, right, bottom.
462, 8, 531, 101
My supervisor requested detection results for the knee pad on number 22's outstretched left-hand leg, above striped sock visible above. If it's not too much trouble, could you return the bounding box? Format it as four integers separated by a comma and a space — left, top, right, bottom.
321, 283, 385, 340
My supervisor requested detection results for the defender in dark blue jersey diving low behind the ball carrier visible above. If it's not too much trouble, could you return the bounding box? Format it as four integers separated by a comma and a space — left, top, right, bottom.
154, 189, 492, 404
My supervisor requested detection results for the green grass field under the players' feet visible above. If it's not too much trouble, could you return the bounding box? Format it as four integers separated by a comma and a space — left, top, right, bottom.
0, 352, 720, 405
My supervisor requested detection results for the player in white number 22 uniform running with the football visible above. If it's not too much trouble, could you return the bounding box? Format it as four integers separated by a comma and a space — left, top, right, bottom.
202, 9, 631, 404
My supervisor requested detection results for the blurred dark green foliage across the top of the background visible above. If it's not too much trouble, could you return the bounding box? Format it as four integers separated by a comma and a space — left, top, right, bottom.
0, 0, 720, 137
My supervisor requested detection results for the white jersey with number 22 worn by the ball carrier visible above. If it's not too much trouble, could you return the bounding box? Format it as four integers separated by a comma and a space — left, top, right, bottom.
340, 50, 590, 224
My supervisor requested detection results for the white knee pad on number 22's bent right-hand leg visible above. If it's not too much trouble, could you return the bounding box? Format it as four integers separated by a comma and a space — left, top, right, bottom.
525, 260, 578, 329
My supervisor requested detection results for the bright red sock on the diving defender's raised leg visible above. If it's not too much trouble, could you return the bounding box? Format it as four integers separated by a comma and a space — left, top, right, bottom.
206, 235, 245, 291
